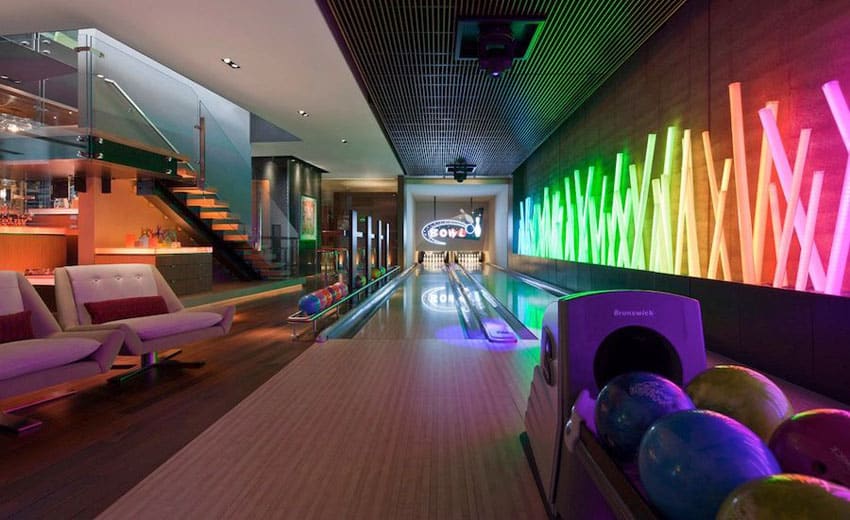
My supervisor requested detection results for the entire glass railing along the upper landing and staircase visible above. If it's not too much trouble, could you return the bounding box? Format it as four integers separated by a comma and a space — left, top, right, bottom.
0, 29, 251, 221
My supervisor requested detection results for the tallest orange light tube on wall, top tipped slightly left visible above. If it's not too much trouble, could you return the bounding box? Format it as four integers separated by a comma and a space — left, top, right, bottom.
729, 83, 757, 283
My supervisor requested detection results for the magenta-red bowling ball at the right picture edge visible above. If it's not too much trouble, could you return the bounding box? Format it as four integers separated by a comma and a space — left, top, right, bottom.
770, 408, 850, 490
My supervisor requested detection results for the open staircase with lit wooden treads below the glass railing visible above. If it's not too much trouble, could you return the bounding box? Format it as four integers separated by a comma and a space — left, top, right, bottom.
169, 187, 286, 280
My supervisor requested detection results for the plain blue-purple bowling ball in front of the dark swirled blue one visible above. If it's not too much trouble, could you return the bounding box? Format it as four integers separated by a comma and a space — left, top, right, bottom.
640, 410, 780, 520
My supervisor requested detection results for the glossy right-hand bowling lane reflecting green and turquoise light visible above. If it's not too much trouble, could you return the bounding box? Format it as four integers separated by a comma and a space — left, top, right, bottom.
470, 265, 558, 337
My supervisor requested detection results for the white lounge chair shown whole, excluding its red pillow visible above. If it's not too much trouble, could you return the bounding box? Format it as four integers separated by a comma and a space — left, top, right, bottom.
55, 264, 235, 381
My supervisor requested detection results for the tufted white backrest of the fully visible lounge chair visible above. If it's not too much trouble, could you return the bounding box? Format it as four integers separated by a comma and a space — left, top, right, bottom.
68, 264, 158, 324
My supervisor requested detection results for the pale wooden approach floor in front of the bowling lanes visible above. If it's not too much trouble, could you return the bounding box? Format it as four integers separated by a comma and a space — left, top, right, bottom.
103, 339, 545, 519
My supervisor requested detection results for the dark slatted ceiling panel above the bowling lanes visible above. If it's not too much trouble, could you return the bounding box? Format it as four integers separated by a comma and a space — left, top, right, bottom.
318, 0, 684, 175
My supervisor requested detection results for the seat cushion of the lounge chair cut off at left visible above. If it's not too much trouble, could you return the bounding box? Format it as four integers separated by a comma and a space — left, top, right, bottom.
0, 337, 100, 381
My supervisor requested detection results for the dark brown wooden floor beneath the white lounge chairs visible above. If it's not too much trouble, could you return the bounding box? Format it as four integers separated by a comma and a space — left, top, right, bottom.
0, 294, 310, 519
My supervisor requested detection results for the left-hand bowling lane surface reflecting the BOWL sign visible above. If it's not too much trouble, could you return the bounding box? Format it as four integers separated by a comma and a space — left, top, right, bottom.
354, 266, 464, 339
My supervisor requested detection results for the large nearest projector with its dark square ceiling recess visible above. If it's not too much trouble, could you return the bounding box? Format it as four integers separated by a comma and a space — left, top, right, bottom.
455, 17, 545, 76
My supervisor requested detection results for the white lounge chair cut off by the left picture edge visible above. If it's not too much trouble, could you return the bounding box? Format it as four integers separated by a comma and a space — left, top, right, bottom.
0, 271, 124, 433
